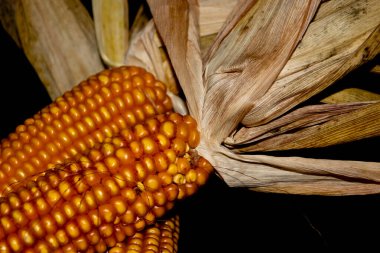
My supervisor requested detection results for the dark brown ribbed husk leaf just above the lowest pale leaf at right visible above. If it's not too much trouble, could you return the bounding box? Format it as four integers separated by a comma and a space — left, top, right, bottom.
229, 102, 380, 152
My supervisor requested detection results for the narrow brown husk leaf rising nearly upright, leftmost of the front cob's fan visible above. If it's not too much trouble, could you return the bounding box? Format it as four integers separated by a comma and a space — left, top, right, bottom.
147, 0, 205, 122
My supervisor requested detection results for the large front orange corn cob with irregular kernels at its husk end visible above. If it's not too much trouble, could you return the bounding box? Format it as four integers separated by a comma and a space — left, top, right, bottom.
0, 112, 212, 252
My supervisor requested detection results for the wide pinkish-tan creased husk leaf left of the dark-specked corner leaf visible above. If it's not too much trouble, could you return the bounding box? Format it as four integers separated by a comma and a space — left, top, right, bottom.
201, 1, 319, 143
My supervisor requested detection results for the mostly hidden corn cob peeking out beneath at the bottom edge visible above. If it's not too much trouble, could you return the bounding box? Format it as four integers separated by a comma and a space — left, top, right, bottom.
108, 216, 179, 253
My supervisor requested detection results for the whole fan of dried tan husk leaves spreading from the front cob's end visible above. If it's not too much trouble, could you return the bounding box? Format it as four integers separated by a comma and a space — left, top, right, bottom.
148, 0, 380, 195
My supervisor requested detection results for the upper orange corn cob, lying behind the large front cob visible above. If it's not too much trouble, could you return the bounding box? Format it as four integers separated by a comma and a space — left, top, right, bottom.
0, 66, 172, 196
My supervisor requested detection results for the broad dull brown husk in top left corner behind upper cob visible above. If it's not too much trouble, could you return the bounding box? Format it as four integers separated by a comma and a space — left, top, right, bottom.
1, 0, 104, 99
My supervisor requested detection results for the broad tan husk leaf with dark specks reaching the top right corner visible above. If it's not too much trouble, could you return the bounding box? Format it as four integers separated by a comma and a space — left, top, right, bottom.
243, 0, 380, 126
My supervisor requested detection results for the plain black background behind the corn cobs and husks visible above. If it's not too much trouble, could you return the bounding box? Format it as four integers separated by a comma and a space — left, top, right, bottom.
0, 1, 380, 253
